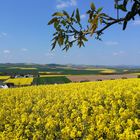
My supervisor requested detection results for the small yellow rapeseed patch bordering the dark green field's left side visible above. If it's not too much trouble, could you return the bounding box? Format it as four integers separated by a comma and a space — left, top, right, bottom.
4, 78, 33, 86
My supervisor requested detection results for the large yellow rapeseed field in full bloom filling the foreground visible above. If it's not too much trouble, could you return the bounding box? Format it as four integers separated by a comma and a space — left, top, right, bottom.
0, 79, 140, 140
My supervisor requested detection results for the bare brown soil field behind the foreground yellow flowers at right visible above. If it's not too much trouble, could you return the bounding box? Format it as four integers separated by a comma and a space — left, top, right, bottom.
67, 74, 137, 82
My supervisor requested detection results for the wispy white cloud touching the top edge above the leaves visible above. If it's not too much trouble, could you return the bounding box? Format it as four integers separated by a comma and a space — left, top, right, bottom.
56, 0, 77, 9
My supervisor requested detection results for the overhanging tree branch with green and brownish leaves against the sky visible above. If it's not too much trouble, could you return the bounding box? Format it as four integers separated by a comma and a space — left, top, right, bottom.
48, 0, 140, 51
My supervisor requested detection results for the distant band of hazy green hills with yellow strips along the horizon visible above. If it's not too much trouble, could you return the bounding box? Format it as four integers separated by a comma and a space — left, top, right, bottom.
0, 64, 140, 76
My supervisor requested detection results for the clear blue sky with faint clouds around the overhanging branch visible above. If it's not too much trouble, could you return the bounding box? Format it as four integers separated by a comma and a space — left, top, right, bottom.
0, 0, 140, 65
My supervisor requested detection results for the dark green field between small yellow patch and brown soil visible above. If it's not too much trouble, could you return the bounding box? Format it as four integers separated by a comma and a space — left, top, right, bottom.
33, 76, 71, 85
